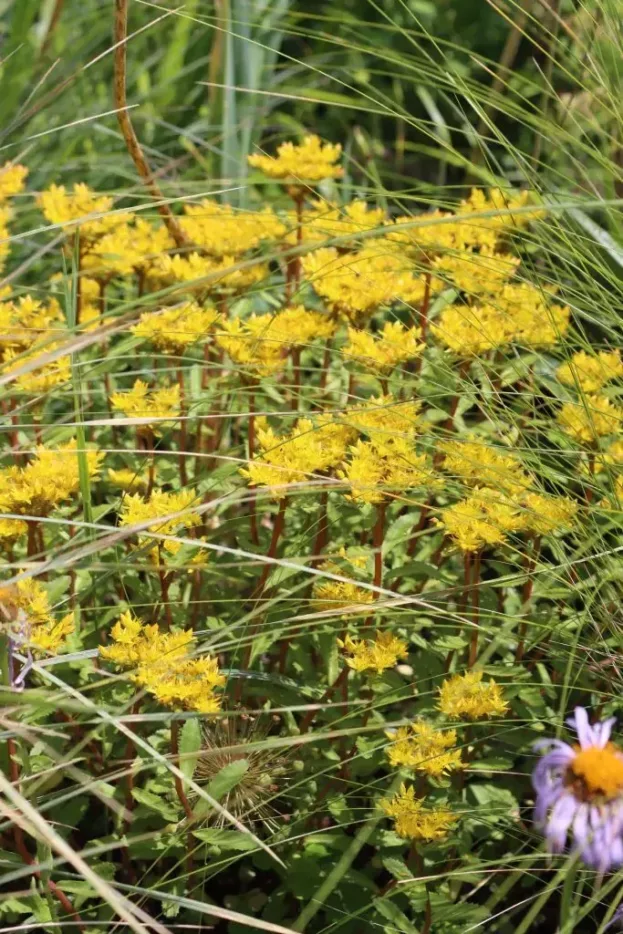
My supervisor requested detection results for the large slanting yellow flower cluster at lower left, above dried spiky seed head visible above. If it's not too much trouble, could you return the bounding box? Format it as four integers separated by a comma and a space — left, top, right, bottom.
100, 612, 225, 714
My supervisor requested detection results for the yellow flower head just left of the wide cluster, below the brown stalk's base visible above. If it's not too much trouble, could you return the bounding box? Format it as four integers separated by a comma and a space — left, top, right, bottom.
130, 302, 220, 354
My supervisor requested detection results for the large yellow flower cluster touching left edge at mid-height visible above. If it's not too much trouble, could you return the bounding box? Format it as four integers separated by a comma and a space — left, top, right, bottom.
0, 440, 103, 516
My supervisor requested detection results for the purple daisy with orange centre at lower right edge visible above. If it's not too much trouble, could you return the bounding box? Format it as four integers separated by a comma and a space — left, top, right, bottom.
532, 707, 623, 872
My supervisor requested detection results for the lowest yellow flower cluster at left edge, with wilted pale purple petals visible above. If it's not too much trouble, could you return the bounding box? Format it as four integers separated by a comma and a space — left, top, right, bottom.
0, 578, 75, 655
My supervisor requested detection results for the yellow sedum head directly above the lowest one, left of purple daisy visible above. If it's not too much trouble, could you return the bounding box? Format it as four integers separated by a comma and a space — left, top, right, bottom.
386, 721, 463, 778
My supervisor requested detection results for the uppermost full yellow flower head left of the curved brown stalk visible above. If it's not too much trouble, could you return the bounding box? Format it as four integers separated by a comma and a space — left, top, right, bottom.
37, 182, 132, 240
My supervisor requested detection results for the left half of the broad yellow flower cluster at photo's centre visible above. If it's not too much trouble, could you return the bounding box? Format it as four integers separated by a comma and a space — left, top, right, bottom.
240, 415, 354, 498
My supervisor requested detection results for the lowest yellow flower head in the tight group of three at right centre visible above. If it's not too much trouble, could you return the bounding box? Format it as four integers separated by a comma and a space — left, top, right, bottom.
435, 489, 525, 552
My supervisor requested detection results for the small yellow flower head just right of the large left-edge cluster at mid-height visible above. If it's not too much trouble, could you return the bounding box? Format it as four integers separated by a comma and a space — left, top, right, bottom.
121, 490, 201, 561
